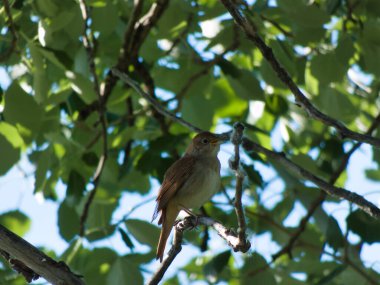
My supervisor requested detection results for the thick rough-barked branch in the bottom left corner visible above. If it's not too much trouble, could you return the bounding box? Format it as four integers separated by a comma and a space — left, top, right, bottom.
0, 225, 85, 285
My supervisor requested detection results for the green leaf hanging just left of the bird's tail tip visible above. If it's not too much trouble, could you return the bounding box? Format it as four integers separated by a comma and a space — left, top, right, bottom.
125, 219, 160, 248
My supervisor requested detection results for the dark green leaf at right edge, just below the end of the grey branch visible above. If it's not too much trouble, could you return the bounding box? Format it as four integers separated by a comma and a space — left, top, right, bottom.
347, 210, 380, 244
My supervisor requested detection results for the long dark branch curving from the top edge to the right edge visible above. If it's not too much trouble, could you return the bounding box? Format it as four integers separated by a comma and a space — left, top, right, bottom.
220, 0, 380, 147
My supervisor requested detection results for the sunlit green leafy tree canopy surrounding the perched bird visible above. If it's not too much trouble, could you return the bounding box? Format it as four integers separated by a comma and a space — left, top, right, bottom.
0, 0, 380, 285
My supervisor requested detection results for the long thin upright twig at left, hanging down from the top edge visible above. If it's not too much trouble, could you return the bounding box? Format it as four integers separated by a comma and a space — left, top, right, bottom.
79, 0, 108, 236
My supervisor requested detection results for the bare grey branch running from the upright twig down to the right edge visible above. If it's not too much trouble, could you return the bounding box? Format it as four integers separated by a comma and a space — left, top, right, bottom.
242, 138, 380, 218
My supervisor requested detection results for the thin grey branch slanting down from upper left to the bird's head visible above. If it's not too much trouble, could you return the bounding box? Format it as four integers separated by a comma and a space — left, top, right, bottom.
112, 68, 202, 133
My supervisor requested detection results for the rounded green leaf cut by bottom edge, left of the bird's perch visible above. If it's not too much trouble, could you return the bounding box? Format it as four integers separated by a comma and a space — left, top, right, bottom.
107, 257, 144, 285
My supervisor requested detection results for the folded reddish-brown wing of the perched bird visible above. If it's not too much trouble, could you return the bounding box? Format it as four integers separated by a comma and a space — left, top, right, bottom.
152, 156, 196, 220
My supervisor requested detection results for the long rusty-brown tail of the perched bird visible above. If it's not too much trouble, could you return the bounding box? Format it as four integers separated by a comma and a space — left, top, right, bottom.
156, 204, 179, 262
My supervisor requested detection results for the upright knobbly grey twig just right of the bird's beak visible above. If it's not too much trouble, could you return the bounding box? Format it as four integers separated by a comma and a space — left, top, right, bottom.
229, 123, 251, 252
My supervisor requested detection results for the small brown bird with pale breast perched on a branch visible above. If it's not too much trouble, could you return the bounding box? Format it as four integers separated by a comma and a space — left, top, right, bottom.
152, 132, 228, 262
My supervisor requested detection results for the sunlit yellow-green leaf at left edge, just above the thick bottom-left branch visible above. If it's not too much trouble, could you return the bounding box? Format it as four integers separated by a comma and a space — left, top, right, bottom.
0, 211, 31, 236
